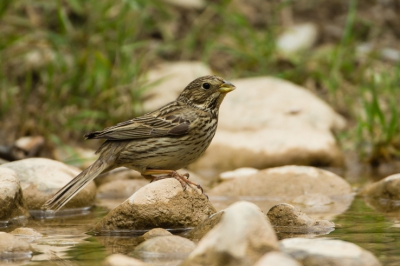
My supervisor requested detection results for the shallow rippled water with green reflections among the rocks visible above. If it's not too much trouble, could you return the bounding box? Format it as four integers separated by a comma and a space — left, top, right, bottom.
0, 194, 400, 265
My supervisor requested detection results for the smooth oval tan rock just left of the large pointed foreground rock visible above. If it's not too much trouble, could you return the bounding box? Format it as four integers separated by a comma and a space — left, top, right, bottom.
133, 235, 196, 265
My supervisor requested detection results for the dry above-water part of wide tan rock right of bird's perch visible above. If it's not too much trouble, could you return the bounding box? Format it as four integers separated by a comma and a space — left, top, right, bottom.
209, 165, 352, 199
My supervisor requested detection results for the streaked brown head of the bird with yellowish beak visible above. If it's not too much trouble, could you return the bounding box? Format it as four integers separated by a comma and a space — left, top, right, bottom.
178, 76, 236, 111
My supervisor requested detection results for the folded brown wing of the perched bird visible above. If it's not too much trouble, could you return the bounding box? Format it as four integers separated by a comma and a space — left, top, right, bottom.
85, 102, 195, 140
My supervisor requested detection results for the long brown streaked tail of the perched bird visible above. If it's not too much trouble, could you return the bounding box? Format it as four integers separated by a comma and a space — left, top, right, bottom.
42, 157, 110, 212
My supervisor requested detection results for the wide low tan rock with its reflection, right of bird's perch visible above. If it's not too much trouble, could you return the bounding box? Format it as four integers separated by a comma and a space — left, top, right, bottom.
211, 166, 354, 219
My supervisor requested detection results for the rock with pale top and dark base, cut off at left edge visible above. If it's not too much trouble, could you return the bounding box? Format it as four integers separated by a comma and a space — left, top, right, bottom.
0, 166, 29, 223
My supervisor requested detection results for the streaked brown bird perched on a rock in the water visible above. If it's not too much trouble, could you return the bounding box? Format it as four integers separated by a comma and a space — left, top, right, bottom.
42, 75, 236, 212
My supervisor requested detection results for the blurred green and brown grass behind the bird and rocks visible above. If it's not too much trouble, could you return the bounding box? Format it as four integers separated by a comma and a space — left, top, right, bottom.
0, 0, 400, 163
